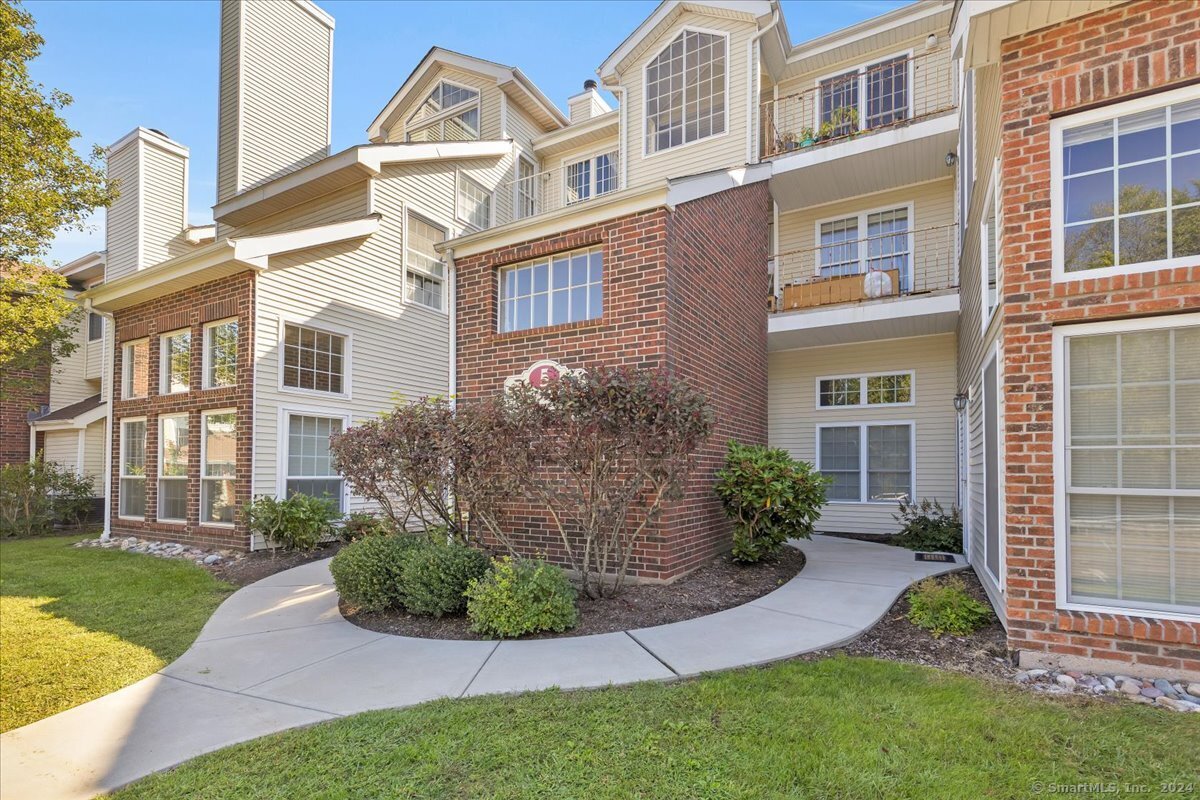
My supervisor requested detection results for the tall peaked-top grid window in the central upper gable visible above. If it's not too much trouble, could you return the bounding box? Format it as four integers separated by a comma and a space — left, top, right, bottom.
646, 30, 728, 155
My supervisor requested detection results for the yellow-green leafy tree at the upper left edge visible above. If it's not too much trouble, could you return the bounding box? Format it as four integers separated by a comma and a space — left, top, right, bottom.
0, 0, 115, 261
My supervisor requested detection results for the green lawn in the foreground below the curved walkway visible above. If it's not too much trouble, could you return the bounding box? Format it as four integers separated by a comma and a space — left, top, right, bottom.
116, 657, 1200, 800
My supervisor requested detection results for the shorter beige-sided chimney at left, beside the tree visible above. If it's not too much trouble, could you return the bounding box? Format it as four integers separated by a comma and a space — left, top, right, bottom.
104, 127, 188, 281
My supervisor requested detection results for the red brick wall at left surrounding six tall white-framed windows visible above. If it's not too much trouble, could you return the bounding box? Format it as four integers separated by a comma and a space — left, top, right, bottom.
109, 272, 254, 548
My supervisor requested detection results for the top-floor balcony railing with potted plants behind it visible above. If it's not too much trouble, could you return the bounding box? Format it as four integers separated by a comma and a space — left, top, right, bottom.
761, 48, 956, 158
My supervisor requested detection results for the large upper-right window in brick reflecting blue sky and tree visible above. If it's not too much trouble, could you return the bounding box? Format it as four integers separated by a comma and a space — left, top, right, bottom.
1050, 88, 1200, 281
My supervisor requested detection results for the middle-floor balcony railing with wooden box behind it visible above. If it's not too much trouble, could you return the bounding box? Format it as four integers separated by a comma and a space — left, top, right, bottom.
770, 224, 958, 312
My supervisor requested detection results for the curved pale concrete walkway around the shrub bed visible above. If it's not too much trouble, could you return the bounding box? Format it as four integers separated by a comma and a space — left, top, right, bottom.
0, 536, 964, 800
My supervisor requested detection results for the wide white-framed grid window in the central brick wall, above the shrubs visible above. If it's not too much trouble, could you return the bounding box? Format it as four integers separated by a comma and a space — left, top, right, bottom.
500, 247, 604, 333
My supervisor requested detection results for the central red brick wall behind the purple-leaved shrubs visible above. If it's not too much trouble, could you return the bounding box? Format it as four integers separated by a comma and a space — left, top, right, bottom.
456, 184, 769, 578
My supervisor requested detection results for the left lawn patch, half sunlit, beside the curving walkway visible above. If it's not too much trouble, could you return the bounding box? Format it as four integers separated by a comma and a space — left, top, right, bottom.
0, 535, 233, 730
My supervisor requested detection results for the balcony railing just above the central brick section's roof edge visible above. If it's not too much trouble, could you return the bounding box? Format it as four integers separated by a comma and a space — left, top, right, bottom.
494, 151, 620, 225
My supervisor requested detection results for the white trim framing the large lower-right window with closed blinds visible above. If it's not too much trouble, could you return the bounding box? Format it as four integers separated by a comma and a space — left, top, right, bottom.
1051, 313, 1200, 622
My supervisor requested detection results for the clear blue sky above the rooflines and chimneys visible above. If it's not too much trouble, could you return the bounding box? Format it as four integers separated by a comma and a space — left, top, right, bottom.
25, 0, 904, 261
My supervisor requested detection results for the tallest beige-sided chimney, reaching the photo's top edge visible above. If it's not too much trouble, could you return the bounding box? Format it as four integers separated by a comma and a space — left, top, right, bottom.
217, 0, 334, 203
